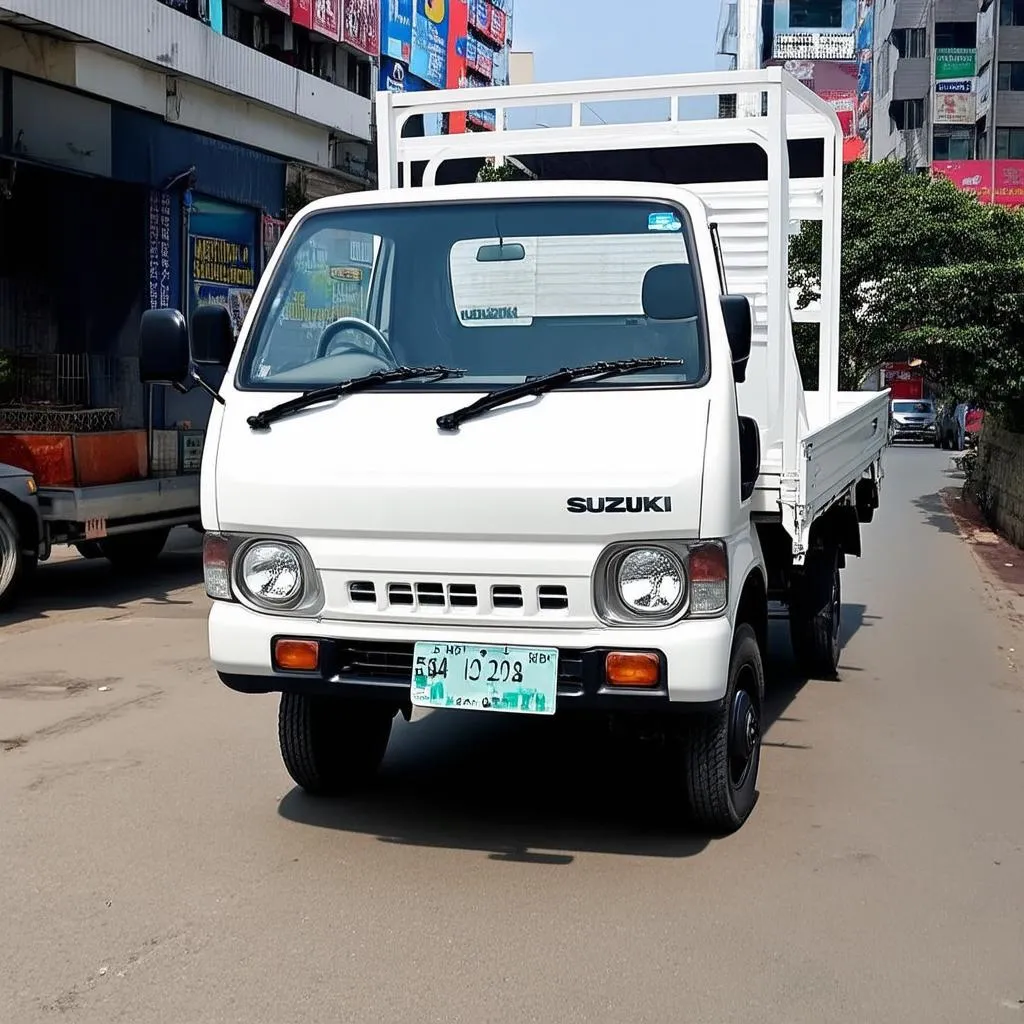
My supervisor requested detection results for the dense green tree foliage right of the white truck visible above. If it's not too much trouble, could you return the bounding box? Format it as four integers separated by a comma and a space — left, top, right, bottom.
790, 162, 1024, 420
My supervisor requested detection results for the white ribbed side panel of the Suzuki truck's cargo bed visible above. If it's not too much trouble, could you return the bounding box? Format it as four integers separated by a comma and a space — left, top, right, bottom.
799, 391, 889, 526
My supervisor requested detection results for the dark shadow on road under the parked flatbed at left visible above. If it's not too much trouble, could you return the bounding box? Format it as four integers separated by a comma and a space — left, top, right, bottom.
0, 530, 206, 628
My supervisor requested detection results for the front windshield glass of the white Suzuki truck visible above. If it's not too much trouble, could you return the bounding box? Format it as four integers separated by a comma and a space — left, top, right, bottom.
239, 200, 708, 391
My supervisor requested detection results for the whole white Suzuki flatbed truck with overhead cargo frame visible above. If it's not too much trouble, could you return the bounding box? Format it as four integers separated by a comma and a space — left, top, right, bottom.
141, 69, 888, 831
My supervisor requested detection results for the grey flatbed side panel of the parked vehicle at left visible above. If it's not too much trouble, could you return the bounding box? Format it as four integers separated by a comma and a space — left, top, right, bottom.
39, 473, 200, 522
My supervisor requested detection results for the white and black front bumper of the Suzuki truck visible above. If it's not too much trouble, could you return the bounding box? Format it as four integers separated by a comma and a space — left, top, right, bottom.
209, 601, 732, 712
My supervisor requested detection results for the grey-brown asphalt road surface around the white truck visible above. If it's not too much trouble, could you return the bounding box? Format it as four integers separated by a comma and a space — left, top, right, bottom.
0, 449, 1024, 1024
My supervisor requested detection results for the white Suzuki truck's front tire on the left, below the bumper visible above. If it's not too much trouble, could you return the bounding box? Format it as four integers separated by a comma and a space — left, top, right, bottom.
278, 693, 395, 797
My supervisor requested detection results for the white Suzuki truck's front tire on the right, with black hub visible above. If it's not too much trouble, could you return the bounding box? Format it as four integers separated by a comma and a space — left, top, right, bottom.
680, 623, 765, 836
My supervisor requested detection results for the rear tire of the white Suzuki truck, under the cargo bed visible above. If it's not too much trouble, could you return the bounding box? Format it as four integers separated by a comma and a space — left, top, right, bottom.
790, 547, 843, 679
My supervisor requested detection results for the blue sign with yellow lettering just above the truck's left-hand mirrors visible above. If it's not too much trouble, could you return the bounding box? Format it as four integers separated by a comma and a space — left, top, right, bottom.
188, 199, 256, 336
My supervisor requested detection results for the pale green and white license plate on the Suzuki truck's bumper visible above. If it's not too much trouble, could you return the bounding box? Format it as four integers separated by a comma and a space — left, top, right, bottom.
413, 643, 558, 715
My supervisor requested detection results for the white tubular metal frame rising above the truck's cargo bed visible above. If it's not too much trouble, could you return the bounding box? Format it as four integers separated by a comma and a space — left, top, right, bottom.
377, 68, 843, 419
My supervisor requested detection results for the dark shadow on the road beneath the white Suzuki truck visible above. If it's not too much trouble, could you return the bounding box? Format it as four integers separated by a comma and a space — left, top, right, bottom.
279, 604, 865, 866
